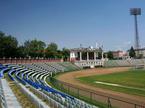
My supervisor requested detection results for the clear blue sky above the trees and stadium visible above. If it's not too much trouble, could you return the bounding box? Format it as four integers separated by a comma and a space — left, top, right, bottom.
0, 0, 145, 50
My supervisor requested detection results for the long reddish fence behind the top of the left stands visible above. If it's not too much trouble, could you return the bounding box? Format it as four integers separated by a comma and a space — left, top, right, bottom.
0, 58, 62, 64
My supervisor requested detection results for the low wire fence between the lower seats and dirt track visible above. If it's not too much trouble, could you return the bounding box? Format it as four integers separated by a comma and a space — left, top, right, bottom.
50, 78, 145, 108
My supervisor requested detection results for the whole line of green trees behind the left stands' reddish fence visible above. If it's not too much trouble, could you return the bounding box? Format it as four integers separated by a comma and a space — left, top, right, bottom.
0, 32, 69, 60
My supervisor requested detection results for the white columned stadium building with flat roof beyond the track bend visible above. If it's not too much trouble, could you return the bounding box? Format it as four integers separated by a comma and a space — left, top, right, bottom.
70, 47, 103, 68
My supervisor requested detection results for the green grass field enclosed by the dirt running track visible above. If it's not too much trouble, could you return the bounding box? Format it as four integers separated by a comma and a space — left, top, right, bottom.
77, 70, 145, 97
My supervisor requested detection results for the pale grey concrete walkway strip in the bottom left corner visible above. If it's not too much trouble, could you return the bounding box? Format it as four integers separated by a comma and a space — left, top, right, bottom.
1, 79, 22, 108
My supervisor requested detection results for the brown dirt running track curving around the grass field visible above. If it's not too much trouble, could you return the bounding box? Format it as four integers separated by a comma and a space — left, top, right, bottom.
57, 67, 145, 108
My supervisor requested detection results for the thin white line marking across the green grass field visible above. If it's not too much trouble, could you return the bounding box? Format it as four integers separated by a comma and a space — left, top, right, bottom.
95, 81, 145, 91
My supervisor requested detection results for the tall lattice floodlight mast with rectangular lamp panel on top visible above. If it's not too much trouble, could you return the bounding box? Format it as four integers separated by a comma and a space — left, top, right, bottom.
130, 8, 141, 56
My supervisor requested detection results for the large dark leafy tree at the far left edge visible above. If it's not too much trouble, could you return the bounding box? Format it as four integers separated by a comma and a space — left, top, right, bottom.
0, 32, 18, 58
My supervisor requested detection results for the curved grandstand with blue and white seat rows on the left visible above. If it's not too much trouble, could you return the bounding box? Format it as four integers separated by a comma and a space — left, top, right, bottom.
0, 62, 97, 108
